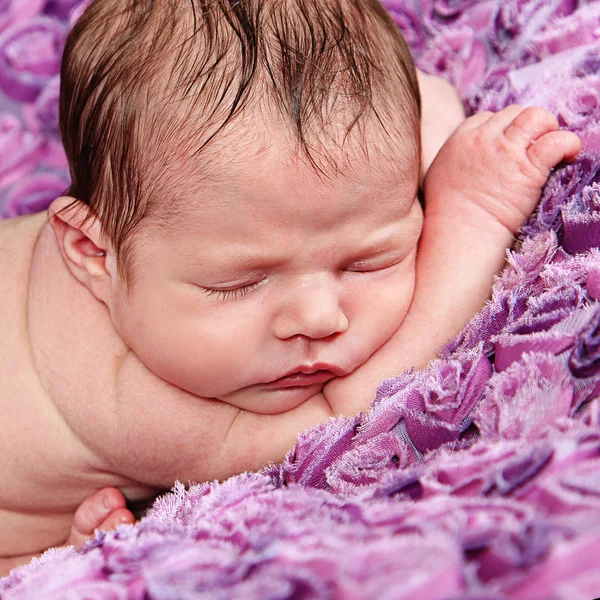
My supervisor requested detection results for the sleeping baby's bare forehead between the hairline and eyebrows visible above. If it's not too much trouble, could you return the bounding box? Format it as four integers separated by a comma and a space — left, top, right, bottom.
147, 132, 419, 237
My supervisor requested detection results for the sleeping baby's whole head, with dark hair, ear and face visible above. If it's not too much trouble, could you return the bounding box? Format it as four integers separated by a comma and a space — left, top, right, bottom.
51, 0, 422, 413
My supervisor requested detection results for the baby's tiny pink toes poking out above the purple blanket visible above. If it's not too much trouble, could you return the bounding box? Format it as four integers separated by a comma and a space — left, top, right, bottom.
66, 488, 135, 548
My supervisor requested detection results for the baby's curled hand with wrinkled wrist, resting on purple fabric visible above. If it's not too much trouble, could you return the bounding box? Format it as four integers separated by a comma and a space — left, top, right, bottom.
425, 105, 581, 234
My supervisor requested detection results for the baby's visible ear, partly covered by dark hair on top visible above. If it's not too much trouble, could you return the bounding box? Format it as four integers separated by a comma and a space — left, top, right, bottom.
48, 196, 116, 305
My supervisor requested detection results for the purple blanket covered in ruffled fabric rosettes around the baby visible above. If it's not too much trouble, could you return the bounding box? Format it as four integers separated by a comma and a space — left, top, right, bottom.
0, 0, 600, 600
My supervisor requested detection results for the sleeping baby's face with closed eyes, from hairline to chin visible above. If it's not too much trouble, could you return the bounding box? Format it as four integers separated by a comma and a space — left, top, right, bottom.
111, 135, 422, 414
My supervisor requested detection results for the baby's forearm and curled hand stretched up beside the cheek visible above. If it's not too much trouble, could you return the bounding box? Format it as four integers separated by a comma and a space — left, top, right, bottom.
325, 106, 581, 414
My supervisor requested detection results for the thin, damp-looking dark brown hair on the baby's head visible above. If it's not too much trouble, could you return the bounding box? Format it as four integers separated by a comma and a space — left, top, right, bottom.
60, 0, 420, 275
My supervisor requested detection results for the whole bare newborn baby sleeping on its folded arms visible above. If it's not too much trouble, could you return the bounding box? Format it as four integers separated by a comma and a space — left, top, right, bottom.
0, 0, 580, 572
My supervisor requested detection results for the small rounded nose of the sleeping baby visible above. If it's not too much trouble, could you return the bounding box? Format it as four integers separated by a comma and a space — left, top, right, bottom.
274, 275, 348, 340
